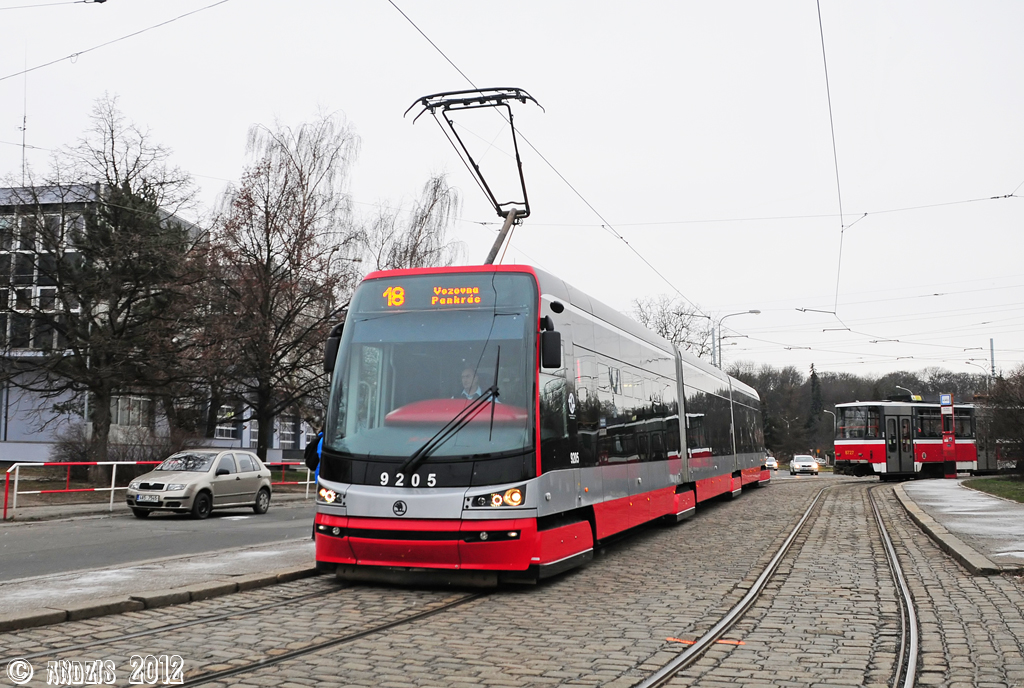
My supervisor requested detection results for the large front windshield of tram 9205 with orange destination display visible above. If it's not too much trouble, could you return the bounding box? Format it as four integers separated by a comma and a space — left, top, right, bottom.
325, 272, 538, 461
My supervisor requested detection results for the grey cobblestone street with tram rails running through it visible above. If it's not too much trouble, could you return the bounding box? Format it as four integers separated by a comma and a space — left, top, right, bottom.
0, 478, 1024, 688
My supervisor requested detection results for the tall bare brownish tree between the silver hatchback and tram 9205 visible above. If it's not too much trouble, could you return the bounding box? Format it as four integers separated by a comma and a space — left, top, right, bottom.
211, 116, 358, 458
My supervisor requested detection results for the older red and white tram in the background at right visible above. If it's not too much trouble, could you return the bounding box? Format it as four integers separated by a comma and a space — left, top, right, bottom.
835, 397, 986, 480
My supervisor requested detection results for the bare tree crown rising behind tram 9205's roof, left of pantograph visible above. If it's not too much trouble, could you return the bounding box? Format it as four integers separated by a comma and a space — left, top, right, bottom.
362, 174, 462, 270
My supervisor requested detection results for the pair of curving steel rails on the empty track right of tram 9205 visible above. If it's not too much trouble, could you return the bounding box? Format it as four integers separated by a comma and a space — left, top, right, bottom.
634, 485, 919, 688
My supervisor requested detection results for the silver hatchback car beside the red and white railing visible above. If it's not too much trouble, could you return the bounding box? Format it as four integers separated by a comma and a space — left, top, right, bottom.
125, 449, 271, 518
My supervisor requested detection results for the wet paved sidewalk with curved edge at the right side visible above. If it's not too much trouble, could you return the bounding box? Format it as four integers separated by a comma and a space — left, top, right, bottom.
896, 479, 1024, 575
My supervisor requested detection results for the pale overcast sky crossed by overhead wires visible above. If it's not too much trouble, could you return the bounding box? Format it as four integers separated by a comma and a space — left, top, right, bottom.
0, 0, 1024, 375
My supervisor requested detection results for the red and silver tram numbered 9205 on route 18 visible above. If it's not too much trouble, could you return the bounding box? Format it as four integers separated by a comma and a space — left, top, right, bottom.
314, 265, 770, 584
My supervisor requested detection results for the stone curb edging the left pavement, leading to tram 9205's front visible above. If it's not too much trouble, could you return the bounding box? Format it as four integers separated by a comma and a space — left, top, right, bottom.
0, 566, 322, 633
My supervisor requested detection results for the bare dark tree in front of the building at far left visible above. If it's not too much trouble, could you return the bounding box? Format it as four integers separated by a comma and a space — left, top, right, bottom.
0, 96, 196, 461
